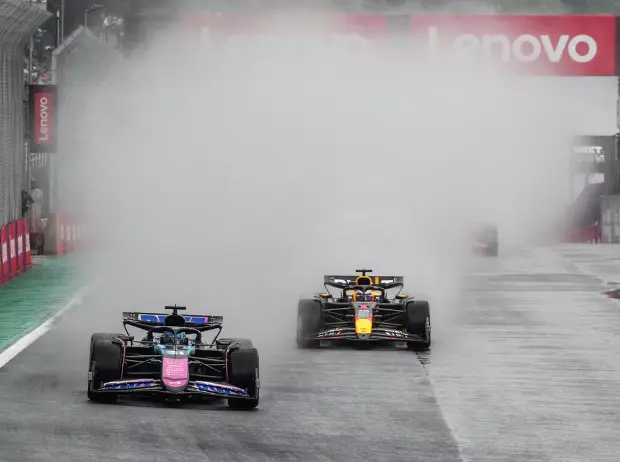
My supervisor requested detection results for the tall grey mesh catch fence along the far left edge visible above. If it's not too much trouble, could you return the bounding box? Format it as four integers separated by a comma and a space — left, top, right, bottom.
0, 0, 51, 227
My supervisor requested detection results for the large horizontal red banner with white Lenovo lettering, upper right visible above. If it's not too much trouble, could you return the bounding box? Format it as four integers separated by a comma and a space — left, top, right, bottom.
410, 15, 616, 76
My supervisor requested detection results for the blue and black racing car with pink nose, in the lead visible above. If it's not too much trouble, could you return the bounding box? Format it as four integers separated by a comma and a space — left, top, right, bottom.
88, 305, 260, 409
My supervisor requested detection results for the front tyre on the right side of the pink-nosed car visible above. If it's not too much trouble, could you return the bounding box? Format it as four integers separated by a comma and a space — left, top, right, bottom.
228, 339, 260, 409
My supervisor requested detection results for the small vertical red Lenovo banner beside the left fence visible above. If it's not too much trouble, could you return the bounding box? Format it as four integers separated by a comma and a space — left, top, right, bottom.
30, 85, 57, 153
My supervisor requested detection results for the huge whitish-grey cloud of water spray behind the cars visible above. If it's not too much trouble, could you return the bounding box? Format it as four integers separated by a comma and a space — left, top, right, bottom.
63, 10, 616, 357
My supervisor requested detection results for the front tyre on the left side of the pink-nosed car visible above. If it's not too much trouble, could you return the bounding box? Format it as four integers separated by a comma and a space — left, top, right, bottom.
87, 334, 123, 402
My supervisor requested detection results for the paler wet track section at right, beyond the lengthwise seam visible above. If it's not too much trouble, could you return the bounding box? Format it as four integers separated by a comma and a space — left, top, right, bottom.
426, 246, 620, 461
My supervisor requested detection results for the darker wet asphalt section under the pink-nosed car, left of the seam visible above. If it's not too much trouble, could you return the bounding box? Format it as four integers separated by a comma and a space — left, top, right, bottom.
0, 288, 459, 462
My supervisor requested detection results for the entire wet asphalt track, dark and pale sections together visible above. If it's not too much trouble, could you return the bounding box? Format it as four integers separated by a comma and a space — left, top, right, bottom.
0, 247, 620, 462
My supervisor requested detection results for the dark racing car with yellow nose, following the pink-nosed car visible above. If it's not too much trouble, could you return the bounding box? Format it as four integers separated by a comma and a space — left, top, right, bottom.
297, 269, 431, 349
